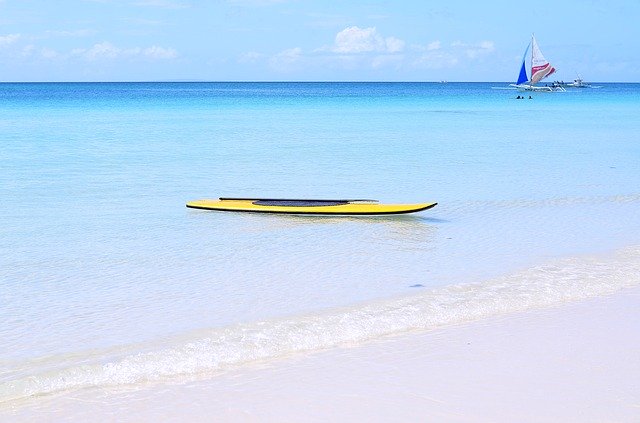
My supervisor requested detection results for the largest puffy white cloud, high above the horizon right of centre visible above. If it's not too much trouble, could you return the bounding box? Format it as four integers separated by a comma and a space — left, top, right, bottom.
329, 26, 405, 54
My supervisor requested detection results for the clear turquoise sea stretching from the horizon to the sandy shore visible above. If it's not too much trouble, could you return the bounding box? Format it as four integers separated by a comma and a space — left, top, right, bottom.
0, 83, 640, 407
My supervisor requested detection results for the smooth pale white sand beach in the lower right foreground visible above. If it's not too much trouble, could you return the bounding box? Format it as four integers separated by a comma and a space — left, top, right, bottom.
6, 287, 640, 422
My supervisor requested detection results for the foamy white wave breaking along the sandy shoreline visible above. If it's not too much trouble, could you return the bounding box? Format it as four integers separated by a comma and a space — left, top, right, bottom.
0, 246, 640, 405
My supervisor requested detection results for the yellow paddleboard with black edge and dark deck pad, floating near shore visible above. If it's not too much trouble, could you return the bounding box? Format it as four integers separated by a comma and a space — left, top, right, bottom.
187, 198, 438, 215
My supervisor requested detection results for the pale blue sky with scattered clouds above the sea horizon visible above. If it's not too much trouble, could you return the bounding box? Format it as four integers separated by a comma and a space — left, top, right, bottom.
0, 0, 640, 82
